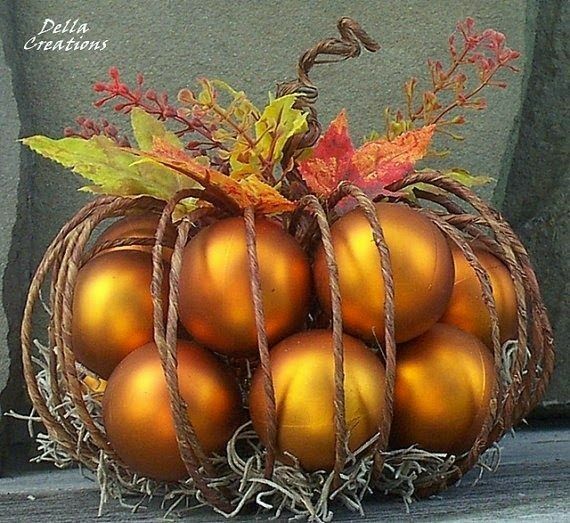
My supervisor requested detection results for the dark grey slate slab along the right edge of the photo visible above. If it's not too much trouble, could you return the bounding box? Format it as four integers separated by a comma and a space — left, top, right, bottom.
503, 0, 570, 412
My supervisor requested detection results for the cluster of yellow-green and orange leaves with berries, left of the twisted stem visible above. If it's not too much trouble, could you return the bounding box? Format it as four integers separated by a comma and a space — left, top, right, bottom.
23, 74, 307, 214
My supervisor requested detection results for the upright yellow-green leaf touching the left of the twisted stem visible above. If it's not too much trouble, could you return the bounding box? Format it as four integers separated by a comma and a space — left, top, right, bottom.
230, 94, 307, 179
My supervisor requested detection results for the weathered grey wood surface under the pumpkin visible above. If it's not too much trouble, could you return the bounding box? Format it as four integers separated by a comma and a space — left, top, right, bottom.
0, 427, 570, 523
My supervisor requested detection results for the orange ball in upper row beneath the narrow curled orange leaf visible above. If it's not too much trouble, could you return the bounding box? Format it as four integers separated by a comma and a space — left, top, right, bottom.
179, 217, 311, 355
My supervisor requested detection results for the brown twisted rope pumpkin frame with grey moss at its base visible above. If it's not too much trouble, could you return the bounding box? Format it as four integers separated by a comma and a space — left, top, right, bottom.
22, 169, 554, 519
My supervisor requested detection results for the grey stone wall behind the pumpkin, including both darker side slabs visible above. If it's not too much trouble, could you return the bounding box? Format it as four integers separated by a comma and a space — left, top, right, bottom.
0, 0, 570, 466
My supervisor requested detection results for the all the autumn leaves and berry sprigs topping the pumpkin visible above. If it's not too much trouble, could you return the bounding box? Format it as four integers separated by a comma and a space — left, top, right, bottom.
23, 18, 519, 214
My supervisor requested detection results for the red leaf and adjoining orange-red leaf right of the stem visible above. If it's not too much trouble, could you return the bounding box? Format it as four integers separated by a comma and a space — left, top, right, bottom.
299, 110, 435, 198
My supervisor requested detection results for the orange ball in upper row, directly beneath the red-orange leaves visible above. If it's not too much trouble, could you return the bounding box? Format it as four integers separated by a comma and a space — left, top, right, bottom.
313, 203, 453, 343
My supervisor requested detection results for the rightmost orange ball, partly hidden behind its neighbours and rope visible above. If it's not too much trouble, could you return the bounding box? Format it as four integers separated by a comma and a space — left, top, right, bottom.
441, 245, 517, 347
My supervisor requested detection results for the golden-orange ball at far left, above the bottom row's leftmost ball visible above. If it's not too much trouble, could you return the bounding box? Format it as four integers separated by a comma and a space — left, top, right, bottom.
72, 249, 168, 379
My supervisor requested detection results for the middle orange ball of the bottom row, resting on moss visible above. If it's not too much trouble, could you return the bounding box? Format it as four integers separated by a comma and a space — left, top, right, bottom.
249, 330, 385, 471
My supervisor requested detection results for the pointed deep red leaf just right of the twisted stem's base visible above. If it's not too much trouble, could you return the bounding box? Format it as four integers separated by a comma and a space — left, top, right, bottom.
299, 110, 354, 196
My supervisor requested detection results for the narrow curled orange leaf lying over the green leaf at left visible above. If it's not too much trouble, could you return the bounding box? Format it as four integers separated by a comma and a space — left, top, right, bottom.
134, 138, 296, 214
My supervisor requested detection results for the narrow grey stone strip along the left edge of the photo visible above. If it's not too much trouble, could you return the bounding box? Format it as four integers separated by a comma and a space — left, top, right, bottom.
0, 3, 32, 467
